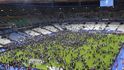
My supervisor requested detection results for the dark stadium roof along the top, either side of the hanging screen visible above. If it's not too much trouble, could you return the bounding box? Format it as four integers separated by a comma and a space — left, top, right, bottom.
0, 0, 124, 9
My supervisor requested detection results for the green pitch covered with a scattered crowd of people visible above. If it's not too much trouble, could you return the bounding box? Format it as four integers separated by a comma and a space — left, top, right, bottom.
0, 32, 124, 70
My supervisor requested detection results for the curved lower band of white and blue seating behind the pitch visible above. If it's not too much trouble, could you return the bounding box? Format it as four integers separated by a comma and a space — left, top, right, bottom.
0, 22, 124, 45
